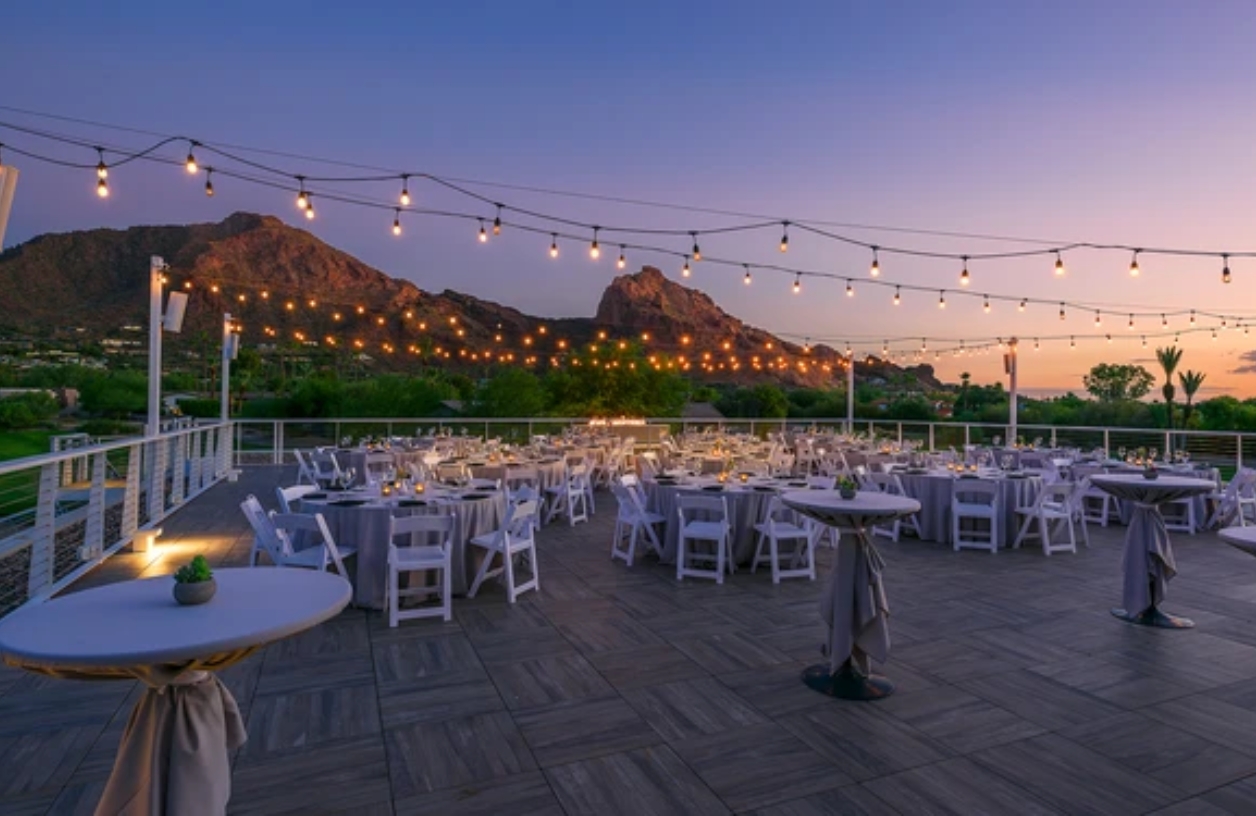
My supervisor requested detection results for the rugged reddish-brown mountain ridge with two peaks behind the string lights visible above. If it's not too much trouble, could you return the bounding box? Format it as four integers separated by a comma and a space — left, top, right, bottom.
0, 212, 938, 388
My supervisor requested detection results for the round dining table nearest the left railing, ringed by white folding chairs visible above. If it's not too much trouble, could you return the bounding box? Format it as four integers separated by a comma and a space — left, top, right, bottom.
300, 483, 506, 609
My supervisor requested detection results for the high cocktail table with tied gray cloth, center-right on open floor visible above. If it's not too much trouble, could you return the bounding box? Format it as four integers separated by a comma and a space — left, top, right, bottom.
781, 490, 921, 701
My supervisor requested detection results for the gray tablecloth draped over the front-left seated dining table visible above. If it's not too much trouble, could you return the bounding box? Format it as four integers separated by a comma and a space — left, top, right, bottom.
301, 491, 506, 609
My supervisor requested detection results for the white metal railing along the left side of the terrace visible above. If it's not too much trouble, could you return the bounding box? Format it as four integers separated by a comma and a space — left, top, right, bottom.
0, 423, 234, 615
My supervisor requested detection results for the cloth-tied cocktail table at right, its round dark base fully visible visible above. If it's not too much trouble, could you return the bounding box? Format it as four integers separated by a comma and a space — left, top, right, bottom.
1090, 473, 1216, 629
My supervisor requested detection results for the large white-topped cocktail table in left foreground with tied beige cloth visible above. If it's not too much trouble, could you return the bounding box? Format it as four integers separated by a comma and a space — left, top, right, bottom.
0, 567, 350, 816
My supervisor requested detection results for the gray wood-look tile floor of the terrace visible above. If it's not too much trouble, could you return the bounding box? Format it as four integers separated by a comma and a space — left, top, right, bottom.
0, 468, 1256, 816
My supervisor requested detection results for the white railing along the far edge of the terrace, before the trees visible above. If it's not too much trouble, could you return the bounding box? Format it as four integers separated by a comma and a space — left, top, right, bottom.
234, 417, 1256, 472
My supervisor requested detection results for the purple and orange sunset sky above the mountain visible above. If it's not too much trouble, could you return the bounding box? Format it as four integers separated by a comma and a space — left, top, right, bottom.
0, 0, 1256, 397
